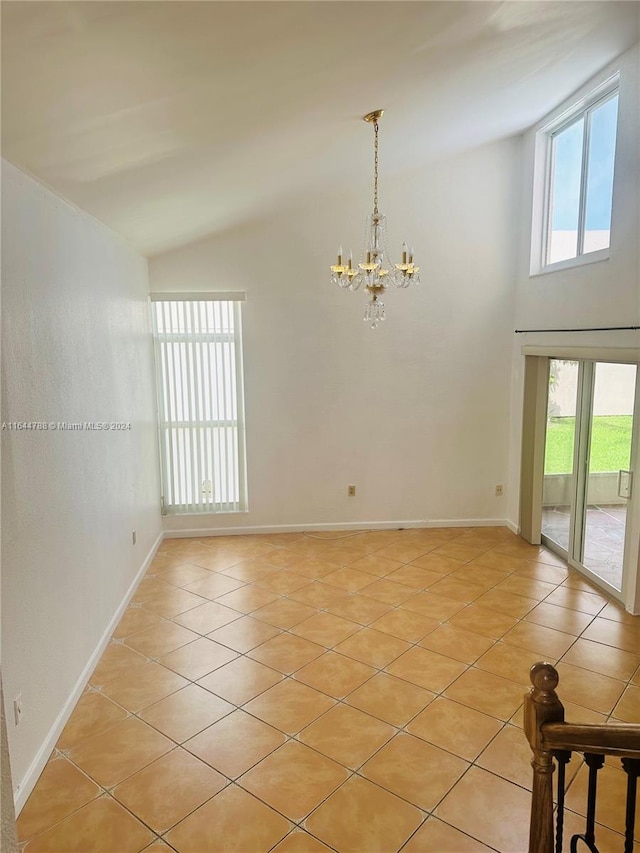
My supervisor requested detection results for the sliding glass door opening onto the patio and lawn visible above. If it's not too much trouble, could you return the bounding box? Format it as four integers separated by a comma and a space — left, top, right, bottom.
542, 359, 636, 595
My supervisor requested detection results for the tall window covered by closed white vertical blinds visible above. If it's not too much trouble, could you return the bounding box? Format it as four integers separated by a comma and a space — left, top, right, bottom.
151, 293, 247, 514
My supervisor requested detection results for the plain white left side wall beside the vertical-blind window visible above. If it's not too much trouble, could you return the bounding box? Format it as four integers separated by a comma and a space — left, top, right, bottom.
2, 163, 160, 803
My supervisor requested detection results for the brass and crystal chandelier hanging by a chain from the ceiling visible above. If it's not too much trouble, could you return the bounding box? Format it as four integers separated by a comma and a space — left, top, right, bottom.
331, 110, 420, 329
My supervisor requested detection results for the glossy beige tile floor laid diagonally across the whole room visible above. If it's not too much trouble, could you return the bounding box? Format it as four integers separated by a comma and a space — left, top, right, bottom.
18, 528, 640, 853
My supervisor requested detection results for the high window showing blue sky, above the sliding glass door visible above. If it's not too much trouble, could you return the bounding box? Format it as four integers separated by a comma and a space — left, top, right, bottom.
541, 80, 618, 268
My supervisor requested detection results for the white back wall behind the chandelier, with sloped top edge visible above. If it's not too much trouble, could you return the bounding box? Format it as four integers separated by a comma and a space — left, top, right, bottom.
150, 140, 519, 530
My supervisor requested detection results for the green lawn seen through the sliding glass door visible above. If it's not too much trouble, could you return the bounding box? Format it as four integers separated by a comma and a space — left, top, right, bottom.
544, 415, 633, 474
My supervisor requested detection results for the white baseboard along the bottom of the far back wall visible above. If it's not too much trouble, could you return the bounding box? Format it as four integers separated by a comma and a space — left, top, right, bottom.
164, 518, 509, 539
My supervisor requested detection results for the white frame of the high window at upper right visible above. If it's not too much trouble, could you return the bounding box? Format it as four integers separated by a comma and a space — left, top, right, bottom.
530, 71, 620, 276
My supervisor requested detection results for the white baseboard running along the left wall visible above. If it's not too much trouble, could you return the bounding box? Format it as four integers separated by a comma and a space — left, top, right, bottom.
14, 533, 163, 816
